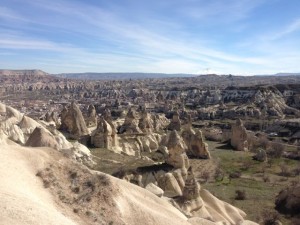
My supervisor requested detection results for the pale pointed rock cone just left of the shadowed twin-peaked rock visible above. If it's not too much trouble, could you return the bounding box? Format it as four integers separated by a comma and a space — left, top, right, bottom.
166, 130, 189, 168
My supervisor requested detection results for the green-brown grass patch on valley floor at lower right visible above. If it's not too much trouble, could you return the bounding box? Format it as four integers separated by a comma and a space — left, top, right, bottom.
202, 141, 300, 225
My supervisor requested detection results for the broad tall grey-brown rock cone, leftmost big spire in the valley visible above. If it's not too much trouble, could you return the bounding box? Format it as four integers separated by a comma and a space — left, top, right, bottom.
60, 102, 89, 138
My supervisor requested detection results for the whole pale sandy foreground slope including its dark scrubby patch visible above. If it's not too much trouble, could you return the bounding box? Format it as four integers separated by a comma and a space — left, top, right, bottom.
0, 137, 189, 225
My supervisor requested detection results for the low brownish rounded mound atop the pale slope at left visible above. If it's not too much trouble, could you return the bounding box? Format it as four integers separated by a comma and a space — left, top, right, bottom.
25, 127, 59, 150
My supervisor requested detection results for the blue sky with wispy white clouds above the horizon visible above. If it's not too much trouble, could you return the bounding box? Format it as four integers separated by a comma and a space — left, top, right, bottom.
0, 0, 300, 75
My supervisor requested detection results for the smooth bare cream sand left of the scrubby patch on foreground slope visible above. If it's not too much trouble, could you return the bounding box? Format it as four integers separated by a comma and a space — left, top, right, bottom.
0, 145, 75, 225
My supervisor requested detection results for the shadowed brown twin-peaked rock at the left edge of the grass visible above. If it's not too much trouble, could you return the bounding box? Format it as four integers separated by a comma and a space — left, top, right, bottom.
182, 127, 210, 159
